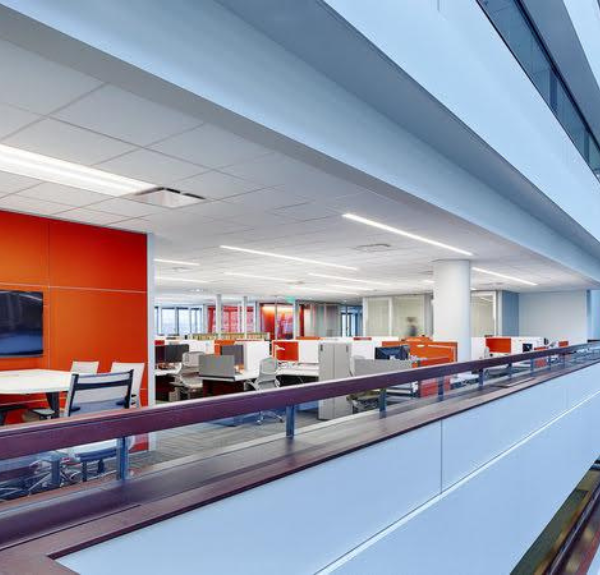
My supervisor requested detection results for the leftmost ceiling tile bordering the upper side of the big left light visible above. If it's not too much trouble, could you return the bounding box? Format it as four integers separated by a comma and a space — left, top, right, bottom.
4, 118, 134, 166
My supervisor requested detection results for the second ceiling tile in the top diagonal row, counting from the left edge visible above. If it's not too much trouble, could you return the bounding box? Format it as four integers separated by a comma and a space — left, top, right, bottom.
54, 85, 201, 146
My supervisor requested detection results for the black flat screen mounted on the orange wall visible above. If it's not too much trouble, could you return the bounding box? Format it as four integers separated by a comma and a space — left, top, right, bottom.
0, 290, 44, 358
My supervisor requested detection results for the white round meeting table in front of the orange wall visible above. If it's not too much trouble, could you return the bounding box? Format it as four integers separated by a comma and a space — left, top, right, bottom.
0, 369, 71, 417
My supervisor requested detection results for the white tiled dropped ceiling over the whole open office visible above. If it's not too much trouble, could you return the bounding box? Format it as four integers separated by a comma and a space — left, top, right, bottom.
0, 5, 592, 301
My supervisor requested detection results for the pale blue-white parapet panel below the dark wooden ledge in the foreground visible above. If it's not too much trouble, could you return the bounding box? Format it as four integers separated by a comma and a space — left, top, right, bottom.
59, 365, 600, 575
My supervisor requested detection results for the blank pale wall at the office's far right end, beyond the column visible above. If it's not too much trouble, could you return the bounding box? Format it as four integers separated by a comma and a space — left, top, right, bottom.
519, 290, 588, 344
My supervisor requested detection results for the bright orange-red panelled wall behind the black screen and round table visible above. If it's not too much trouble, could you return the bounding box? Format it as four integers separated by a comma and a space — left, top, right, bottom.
0, 211, 148, 420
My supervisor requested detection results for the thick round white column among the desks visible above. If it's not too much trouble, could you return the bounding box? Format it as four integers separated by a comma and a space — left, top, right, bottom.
433, 260, 471, 361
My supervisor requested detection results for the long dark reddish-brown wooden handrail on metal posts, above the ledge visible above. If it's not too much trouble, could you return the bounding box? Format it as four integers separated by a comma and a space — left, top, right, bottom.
0, 344, 600, 459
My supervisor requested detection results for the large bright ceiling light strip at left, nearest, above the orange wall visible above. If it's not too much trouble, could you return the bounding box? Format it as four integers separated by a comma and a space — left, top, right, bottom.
0, 144, 156, 196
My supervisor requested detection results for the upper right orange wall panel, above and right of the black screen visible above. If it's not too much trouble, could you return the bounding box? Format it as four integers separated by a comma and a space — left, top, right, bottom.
49, 220, 147, 292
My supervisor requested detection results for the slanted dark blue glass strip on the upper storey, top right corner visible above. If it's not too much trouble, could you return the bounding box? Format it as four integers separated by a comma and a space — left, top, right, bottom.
477, 0, 600, 179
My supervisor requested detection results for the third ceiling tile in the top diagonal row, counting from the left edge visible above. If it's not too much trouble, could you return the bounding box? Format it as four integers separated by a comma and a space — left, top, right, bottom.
152, 124, 271, 168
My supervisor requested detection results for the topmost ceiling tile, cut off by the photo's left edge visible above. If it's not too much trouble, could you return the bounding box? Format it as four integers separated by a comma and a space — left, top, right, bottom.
0, 41, 102, 114
